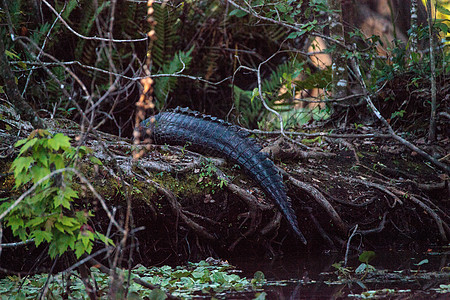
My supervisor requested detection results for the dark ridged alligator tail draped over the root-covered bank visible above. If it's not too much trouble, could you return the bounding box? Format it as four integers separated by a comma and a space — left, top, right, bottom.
141, 107, 306, 244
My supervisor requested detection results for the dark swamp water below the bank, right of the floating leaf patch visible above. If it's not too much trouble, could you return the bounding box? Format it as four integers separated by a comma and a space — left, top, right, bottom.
223, 247, 450, 299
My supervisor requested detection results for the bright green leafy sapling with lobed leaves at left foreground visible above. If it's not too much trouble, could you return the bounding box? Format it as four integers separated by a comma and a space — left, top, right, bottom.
0, 129, 112, 258
